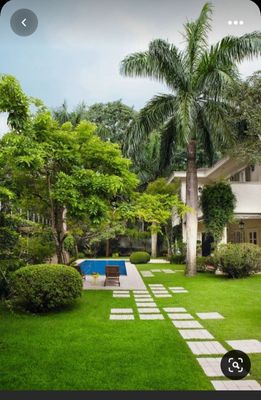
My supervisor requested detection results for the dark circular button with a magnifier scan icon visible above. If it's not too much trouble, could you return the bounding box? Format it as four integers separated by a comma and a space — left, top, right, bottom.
220, 350, 251, 381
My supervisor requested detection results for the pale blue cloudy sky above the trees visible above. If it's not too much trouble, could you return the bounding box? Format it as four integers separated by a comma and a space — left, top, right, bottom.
0, 0, 261, 134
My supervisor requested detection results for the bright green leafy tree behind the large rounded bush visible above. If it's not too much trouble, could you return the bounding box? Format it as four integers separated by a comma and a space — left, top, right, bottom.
0, 113, 137, 263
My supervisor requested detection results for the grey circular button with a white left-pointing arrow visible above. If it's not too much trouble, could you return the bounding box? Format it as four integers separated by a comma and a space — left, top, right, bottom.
10, 8, 38, 36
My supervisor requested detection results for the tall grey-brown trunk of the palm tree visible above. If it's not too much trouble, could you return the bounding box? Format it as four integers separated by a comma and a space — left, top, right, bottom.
185, 140, 198, 276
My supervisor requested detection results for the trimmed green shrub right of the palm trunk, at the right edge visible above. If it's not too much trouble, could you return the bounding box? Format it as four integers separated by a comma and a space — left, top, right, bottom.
214, 243, 261, 278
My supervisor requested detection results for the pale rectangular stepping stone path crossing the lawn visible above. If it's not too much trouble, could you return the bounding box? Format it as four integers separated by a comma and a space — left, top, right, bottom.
110, 282, 261, 391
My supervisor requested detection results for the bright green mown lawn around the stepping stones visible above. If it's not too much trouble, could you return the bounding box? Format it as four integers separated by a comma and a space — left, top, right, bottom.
0, 264, 261, 390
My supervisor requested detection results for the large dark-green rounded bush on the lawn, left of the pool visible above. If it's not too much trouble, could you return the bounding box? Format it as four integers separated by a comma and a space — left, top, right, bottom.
11, 264, 82, 312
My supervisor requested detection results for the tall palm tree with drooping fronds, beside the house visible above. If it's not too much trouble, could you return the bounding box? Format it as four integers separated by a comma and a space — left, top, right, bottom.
121, 3, 261, 276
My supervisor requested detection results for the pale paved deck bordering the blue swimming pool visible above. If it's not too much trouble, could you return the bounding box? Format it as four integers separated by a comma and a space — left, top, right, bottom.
78, 260, 146, 290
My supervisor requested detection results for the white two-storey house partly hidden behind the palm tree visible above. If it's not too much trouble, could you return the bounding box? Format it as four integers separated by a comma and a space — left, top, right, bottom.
171, 157, 261, 255
